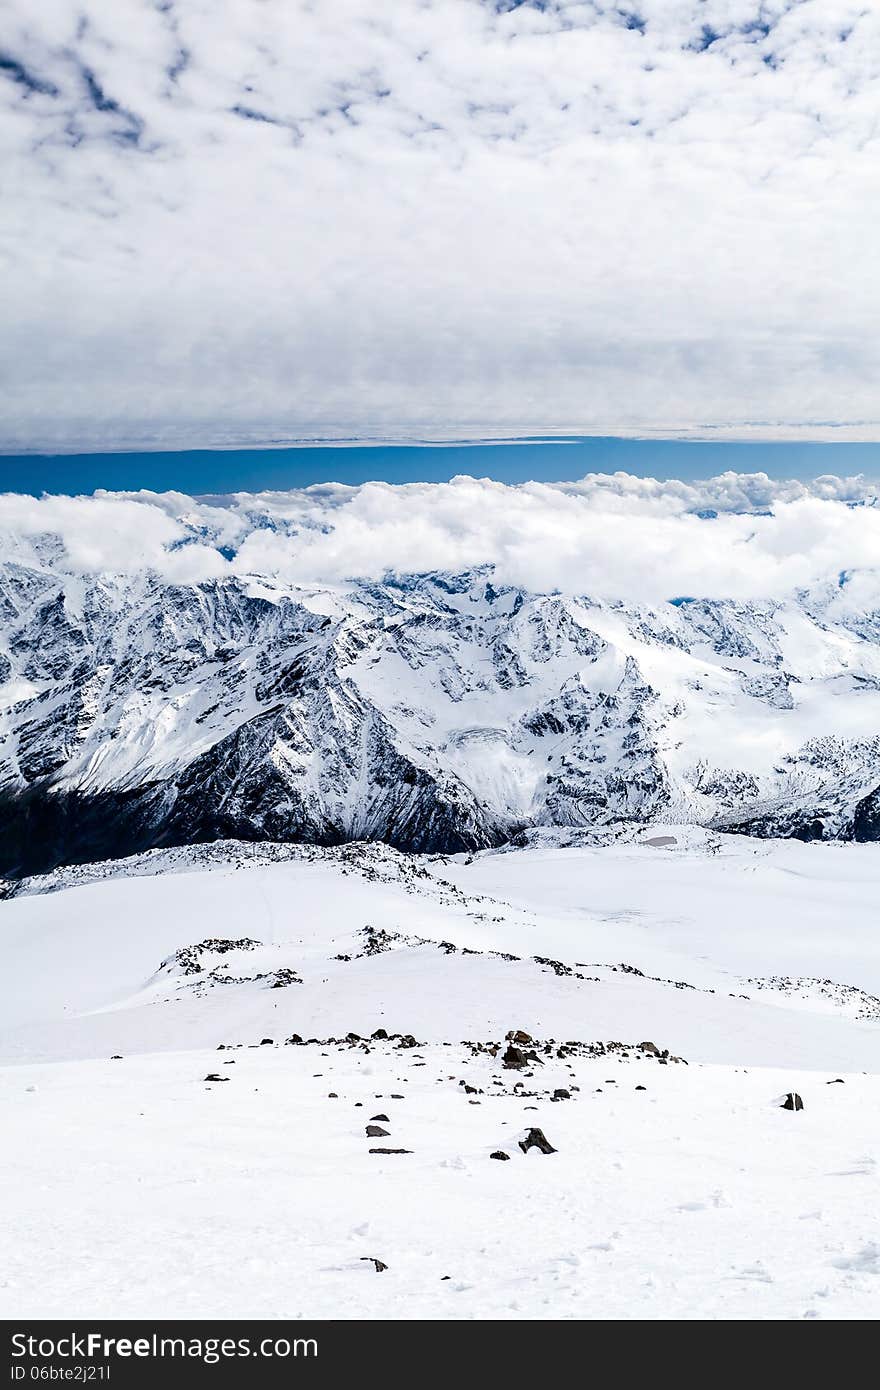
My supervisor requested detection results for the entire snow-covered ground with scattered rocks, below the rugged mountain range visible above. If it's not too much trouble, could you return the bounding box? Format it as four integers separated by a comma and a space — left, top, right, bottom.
0, 824, 880, 1319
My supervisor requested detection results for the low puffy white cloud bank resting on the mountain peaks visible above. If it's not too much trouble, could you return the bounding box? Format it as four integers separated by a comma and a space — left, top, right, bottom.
0, 473, 880, 612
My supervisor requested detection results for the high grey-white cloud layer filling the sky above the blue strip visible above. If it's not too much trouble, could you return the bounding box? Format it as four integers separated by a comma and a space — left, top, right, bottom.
0, 0, 880, 447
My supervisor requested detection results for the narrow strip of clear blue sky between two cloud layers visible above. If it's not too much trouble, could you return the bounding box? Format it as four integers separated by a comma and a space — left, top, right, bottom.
0, 438, 880, 496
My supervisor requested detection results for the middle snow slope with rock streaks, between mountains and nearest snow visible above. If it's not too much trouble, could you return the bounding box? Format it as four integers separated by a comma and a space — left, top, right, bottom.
0, 826, 880, 1070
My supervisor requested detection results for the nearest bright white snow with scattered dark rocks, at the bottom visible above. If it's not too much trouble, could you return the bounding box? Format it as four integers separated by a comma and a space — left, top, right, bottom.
0, 1047, 880, 1319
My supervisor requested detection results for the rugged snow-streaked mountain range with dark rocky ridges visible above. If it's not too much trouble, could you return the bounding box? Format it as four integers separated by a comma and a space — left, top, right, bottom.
0, 538, 880, 874
